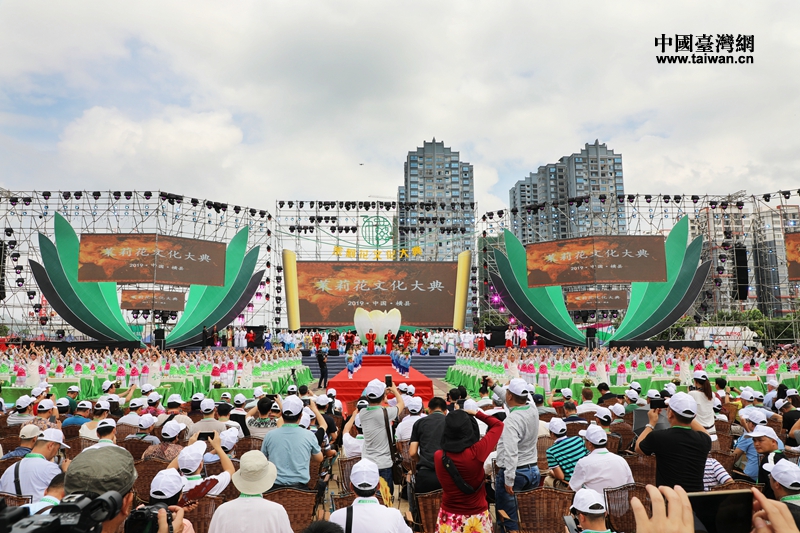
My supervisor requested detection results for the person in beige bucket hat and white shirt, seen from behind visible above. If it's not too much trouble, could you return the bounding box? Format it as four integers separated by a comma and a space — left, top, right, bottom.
208, 450, 292, 533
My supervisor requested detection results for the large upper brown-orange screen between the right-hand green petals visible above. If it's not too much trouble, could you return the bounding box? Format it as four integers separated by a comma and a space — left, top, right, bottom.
525, 235, 667, 287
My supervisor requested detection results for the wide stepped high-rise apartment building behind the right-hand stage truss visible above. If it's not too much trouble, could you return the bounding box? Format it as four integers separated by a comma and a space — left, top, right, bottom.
509, 140, 627, 244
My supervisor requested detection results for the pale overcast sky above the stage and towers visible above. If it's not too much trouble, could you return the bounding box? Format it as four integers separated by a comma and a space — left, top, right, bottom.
0, 0, 800, 210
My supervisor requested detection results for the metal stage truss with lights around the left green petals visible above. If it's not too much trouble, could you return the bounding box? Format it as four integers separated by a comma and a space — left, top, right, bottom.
0, 190, 285, 340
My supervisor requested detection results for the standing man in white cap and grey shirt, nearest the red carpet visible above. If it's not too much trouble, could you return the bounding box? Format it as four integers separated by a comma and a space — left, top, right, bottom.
359, 379, 406, 488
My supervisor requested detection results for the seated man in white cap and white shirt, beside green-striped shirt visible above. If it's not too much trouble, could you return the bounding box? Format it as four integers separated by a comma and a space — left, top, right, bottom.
569, 424, 636, 492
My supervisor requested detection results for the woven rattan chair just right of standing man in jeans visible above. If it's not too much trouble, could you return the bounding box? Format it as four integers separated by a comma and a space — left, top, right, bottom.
516, 487, 575, 533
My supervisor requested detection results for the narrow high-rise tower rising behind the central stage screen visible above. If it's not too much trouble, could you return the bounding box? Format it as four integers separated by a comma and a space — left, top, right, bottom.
397, 138, 475, 261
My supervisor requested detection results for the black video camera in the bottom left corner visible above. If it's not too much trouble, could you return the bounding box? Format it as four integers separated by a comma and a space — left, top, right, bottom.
0, 491, 122, 533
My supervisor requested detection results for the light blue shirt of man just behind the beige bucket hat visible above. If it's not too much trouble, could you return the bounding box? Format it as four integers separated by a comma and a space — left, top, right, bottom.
261, 424, 321, 485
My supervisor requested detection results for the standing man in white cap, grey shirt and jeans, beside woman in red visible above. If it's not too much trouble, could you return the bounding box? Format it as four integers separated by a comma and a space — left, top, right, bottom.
489, 378, 541, 532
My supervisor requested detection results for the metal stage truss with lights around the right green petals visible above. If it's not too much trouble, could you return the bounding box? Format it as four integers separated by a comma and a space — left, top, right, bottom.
476, 190, 800, 345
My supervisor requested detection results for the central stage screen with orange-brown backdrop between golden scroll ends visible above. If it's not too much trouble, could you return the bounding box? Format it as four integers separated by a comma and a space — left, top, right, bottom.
297, 261, 458, 328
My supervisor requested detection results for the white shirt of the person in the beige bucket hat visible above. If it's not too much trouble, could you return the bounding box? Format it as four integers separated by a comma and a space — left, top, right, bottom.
208, 494, 293, 533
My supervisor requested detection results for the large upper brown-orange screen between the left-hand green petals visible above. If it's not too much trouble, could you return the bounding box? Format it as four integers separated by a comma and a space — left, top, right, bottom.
78, 233, 226, 287
